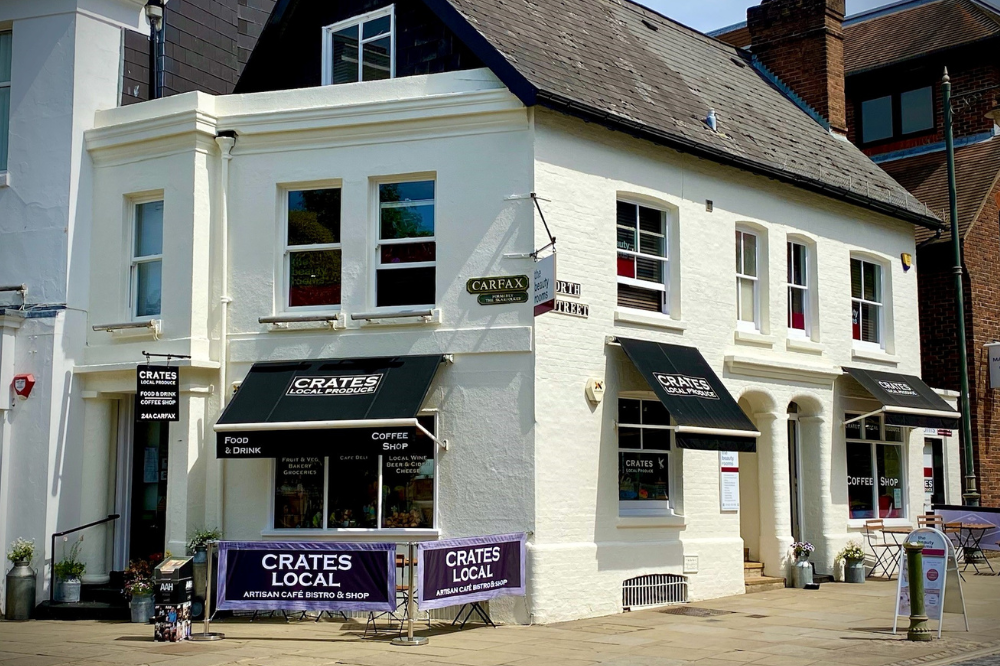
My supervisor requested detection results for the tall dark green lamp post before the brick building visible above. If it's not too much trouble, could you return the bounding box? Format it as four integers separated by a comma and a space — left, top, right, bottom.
941, 67, 979, 506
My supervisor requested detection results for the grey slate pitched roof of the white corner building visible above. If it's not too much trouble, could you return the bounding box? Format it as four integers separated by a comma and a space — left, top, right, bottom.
436, 0, 937, 226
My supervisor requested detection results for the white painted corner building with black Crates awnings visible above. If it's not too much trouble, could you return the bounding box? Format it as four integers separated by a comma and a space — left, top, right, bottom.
3, 0, 959, 622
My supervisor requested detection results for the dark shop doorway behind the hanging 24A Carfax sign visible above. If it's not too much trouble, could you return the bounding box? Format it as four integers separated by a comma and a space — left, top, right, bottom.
115, 399, 170, 571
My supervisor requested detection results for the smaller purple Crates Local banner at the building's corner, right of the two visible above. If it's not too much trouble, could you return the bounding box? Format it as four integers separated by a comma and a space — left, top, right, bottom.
417, 533, 527, 610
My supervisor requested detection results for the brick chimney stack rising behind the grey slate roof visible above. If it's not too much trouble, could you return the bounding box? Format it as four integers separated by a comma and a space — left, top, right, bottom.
747, 0, 847, 135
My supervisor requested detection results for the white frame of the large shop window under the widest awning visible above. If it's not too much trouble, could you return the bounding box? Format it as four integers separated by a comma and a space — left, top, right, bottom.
261, 409, 441, 541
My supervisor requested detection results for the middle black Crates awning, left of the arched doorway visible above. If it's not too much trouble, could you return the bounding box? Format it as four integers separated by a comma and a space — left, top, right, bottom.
618, 338, 760, 452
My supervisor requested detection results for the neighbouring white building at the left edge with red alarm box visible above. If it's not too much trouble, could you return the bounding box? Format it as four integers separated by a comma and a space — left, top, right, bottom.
0, 0, 148, 599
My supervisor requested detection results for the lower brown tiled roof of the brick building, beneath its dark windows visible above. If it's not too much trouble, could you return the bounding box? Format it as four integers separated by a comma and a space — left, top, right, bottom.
882, 137, 1000, 241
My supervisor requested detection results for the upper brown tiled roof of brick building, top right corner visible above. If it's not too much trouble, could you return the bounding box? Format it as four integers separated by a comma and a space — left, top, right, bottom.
844, 0, 1000, 74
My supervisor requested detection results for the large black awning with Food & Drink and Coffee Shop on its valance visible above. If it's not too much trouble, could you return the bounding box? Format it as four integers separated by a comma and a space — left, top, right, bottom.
215, 354, 444, 458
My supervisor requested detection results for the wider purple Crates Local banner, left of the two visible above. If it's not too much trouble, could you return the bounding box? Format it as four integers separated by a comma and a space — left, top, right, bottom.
217, 541, 396, 611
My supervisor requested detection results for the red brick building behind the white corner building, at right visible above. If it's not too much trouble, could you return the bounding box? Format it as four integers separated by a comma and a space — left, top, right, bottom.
714, 0, 1000, 506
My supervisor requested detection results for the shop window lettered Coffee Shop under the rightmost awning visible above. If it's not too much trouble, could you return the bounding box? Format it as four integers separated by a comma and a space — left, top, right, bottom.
845, 414, 906, 520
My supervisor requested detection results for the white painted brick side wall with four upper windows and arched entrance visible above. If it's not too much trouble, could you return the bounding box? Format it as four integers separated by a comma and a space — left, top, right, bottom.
532, 111, 922, 621
